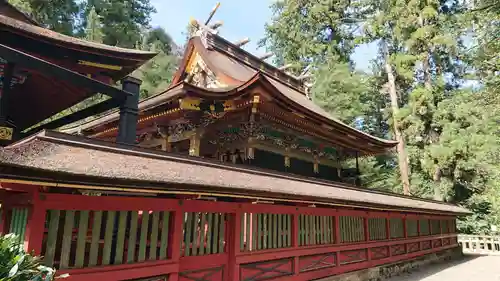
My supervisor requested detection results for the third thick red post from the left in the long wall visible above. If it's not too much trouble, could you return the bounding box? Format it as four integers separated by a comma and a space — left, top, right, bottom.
228, 212, 241, 281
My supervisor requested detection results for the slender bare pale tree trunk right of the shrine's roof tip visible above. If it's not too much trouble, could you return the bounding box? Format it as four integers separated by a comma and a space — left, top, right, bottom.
385, 58, 410, 195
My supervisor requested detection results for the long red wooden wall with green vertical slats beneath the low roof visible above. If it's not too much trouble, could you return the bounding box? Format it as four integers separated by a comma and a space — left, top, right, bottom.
0, 193, 458, 281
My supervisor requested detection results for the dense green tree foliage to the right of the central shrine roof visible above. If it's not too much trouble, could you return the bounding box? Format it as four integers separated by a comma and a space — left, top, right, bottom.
268, 0, 500, 233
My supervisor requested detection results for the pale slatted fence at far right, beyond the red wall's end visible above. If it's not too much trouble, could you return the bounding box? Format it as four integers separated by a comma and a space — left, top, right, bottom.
458, 234, 500, 255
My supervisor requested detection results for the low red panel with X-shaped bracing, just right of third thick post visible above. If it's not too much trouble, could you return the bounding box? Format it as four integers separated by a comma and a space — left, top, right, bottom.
240, 258, 294, 281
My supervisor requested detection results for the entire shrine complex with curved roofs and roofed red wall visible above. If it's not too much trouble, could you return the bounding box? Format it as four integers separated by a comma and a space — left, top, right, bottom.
0, 1, 470, 281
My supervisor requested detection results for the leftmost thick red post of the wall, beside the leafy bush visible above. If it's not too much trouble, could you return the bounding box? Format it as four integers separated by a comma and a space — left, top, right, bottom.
24, 191, 47, 255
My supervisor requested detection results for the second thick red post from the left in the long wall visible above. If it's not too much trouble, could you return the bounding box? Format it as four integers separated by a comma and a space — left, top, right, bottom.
168, 203, 184, 281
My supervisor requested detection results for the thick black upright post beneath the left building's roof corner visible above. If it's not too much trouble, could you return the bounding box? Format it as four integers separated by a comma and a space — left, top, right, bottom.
117, 76, 142, 145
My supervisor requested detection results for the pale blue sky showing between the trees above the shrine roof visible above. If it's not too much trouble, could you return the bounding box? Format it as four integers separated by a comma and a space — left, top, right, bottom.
151, 0, 376, 70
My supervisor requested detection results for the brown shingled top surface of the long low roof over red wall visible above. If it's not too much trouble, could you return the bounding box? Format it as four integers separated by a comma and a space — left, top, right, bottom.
0, 132, 468, 214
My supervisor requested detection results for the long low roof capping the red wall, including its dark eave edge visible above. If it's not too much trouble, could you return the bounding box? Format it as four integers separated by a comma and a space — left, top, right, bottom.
0, 131, 469, 214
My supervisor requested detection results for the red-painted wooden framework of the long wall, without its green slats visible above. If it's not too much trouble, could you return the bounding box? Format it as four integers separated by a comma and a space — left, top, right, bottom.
4, 184, 457, 281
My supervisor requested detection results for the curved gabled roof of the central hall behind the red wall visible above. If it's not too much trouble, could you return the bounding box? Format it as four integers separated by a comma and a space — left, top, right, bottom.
65, 32, 397, 154
